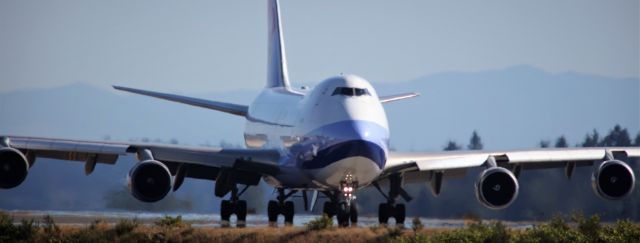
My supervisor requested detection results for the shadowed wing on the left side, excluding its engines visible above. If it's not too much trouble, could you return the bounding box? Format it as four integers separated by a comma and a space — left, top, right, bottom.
0, 136, 280, 184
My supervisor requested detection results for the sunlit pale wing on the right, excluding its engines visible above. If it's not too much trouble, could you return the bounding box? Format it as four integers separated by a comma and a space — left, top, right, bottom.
383, 147, 640, 178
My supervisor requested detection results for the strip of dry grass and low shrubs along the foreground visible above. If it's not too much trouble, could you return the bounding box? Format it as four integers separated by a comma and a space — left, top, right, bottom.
0, 212, 640, 243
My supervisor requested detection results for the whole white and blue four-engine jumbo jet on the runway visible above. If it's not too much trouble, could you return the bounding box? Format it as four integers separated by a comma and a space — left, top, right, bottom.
0, 0, 640, 227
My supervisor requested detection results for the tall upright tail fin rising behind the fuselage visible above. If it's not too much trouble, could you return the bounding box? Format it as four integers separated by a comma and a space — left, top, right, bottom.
267, 0, 289, 88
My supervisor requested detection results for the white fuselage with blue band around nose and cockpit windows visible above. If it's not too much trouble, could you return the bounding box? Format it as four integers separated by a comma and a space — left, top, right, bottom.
244, 75, 389, 189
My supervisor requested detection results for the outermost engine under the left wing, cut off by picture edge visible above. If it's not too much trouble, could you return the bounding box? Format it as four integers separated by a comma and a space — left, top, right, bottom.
0, 148, 29, 189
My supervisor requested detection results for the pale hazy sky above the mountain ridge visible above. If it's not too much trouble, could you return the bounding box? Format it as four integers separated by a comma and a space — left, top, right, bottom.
0, 0, 640, 92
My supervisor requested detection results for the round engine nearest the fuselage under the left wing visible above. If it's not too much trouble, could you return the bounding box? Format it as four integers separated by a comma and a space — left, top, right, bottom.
128, 160, 173, 202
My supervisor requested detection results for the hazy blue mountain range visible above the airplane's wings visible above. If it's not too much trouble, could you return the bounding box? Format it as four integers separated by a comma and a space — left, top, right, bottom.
0, 66, 640, 150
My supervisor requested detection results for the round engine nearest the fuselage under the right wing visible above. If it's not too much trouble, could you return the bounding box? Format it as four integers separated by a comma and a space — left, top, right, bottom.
476, 167, 519, 209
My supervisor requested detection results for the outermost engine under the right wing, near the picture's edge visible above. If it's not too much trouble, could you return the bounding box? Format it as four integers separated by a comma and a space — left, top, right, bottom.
591, 160, 636, 200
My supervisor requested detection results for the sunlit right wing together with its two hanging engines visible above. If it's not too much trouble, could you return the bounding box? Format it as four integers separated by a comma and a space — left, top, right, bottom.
372, 147, 640, 209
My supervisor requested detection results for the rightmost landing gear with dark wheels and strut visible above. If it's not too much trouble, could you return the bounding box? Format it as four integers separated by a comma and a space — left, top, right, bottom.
373, 174, 412, 225
